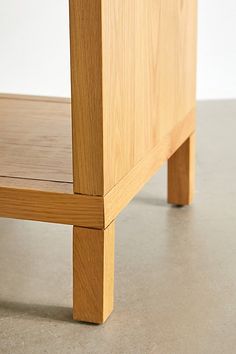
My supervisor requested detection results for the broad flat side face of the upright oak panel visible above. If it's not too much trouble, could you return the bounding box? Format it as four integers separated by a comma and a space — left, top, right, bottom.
102, 0, 196, 194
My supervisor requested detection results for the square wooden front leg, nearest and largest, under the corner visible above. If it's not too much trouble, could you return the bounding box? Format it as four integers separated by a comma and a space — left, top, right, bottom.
73, 223, 115, 323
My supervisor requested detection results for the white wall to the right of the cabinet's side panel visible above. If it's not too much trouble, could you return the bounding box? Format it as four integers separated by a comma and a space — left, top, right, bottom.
198, 0, 236, 99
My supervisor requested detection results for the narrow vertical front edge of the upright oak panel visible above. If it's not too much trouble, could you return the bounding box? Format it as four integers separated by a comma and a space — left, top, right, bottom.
70, 0, 104, 195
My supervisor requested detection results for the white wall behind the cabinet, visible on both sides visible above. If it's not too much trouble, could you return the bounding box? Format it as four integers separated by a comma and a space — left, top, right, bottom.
0, 0, 236, 99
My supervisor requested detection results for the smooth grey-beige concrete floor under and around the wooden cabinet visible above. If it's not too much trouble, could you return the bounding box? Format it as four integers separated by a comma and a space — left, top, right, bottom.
0, 101, 236, 354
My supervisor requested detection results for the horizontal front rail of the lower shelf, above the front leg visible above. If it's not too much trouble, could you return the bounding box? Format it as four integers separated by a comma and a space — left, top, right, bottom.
0, 186, 104, 228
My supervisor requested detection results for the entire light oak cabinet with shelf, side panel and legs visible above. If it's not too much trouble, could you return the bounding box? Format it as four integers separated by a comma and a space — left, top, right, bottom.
0, 0, 197, 323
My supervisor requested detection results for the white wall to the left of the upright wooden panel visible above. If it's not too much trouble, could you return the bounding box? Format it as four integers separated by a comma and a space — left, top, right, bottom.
0, 0, 70, 96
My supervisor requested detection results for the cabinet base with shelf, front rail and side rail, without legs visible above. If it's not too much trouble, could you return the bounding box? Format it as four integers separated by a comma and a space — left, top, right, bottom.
0, 95, 195, 228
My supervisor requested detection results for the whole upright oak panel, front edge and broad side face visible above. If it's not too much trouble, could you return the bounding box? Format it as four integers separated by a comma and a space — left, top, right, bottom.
70, 0, 196, 195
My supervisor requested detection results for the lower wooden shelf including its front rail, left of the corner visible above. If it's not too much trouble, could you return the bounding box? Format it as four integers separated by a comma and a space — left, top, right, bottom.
0, 95, 104, 228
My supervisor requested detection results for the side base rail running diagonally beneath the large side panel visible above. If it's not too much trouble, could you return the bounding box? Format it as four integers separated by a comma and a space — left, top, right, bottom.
104, 110, 195, 226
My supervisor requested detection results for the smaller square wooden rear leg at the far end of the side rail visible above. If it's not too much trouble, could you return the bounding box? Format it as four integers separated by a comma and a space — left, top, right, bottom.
168, 134, 195, 205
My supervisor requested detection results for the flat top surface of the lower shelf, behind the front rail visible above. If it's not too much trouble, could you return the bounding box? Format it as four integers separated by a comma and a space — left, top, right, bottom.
0, 95, 73, 183
